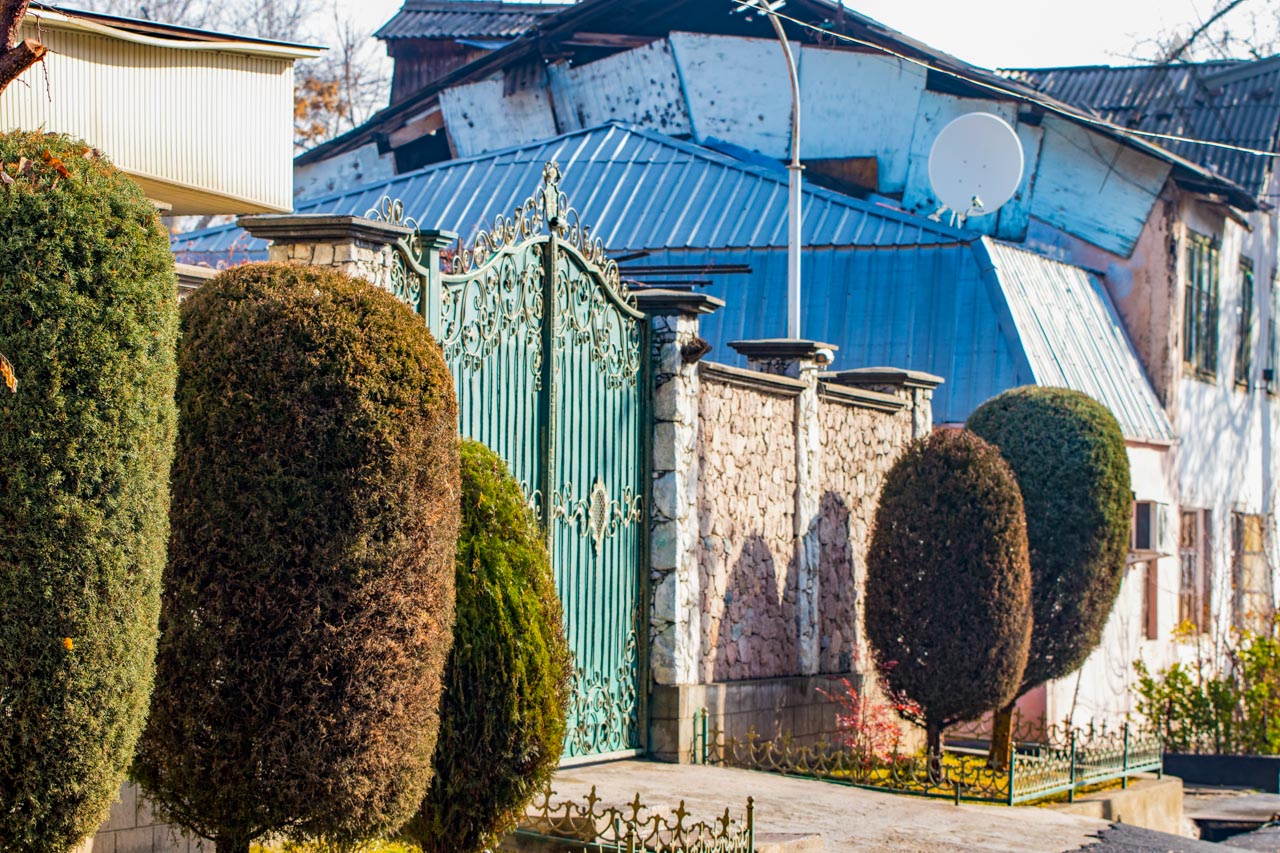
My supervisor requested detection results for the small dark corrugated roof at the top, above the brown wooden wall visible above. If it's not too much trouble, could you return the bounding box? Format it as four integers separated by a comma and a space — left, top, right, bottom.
374, 0, 564, 40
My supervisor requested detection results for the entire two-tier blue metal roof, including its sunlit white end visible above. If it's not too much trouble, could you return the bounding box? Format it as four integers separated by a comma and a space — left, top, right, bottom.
174, 126, 1172, 441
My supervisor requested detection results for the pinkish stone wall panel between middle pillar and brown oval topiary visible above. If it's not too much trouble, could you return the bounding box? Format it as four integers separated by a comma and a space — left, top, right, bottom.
818, 396, 913, 672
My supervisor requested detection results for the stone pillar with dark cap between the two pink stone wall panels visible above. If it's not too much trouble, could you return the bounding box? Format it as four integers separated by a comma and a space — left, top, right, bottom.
730, 338, 837, 675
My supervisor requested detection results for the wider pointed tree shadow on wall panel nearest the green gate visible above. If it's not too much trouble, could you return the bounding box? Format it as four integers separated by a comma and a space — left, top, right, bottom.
713, 534, 797, 681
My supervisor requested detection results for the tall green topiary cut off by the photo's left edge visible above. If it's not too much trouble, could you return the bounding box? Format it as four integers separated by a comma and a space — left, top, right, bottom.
0, 133, 178, 853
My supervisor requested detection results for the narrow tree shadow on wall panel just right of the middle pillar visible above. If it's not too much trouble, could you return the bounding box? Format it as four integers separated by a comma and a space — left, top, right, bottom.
809, 492, 858, 674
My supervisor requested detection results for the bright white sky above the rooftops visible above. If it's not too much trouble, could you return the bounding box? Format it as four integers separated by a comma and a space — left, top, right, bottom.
338, 0, 1267, 68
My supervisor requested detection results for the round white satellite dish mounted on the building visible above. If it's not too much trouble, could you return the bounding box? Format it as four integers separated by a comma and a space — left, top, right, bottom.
929, 113, 1023, 219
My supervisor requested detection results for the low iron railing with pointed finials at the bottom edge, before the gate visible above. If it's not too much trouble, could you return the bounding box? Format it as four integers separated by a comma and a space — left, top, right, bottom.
516, 786, 755, 853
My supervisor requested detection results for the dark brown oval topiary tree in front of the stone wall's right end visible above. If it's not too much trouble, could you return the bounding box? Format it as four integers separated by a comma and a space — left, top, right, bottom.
865, 430, 1032, 758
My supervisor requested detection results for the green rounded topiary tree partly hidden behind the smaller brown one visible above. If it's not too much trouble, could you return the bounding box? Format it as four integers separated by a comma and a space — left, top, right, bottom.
969, 386, 1133, 767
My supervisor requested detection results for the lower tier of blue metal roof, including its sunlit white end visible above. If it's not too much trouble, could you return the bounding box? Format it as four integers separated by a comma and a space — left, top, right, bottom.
645, 238, 1174, 442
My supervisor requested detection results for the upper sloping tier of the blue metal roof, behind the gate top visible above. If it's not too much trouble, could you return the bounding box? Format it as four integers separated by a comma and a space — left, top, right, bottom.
167, 124, 973, 263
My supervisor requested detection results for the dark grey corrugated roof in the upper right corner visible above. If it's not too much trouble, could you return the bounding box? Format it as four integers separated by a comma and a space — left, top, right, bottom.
1005, 56, 1280, 196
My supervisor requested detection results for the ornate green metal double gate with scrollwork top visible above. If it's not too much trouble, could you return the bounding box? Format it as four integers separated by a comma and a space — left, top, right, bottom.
369, 163, 648, 758
